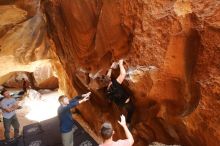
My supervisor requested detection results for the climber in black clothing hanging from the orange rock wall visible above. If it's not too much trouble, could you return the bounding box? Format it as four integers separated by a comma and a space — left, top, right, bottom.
105, 59, 134, 125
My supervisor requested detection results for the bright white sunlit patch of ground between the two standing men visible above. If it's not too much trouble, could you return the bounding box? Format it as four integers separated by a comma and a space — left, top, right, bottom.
24, 91, 59, 122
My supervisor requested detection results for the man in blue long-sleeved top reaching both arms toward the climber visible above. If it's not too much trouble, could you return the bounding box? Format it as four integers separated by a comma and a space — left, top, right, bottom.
58, 92, 91, 146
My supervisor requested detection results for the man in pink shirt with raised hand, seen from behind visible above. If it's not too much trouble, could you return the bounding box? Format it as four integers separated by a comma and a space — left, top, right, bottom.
99, 115, 134, 146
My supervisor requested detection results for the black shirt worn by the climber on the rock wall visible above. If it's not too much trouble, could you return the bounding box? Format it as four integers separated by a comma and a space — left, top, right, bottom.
107, 79, 129, 106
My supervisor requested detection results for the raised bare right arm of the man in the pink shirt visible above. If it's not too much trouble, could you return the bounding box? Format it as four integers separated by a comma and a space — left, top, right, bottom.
118, 115, 134, 145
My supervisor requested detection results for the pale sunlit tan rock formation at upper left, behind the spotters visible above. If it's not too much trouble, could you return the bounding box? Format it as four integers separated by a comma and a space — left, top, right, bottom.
0, 0, 58, 89
